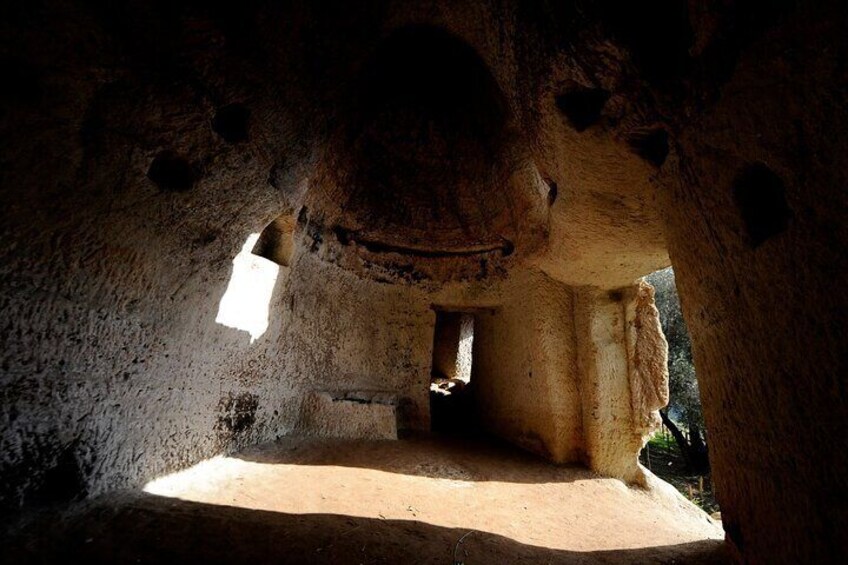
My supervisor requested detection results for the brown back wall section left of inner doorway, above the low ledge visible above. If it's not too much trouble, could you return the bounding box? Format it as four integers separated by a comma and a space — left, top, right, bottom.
278, 248, 436, 432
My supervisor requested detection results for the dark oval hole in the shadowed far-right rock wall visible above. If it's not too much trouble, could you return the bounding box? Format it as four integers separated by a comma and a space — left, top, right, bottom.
733, 163, 792, 247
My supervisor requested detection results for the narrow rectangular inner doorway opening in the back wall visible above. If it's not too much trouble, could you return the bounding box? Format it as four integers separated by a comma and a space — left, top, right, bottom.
430, 310, 475, 435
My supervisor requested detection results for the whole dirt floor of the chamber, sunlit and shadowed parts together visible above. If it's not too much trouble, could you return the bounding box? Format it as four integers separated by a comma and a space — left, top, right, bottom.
0, 438, 727, 564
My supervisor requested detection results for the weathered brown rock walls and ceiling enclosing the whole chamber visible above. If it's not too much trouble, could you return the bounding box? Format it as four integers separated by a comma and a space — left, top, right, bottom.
0, 0, 848, 562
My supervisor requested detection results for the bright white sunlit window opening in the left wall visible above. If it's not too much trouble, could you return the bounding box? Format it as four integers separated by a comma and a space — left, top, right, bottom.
215, 233, 280, 343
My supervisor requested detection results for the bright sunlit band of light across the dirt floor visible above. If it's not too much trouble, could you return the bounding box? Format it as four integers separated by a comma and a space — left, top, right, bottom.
144, 440, 722, 551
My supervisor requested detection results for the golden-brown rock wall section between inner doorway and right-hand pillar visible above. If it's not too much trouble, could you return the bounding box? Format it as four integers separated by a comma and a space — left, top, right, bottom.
471, 271, 584, 463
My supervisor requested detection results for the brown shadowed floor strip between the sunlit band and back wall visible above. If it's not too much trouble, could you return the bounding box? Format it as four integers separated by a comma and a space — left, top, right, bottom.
230, 433, 597, 483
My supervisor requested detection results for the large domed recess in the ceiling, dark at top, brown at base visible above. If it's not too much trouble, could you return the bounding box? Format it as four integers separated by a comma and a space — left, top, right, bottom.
307, 26, 547, 280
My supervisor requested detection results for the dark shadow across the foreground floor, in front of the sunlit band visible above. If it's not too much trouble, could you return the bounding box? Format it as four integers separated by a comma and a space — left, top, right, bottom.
0, 493, 728, 564
